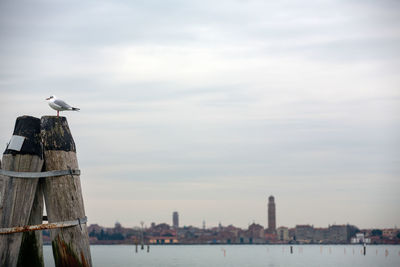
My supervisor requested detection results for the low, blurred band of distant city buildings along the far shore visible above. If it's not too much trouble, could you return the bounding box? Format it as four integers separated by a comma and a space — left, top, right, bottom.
86, 217, 400, 245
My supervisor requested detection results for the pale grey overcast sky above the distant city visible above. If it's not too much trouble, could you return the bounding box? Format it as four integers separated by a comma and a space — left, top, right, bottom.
0, 0, 400, 228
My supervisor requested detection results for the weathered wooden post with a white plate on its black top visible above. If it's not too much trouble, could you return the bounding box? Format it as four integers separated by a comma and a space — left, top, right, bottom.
0, 116, 43, 266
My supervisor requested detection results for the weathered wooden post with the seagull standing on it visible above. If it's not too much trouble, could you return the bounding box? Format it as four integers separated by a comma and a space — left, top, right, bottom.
41, 116, 92, 267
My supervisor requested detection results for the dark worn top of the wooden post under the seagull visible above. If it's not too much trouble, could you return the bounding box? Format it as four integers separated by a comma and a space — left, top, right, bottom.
41, 116, 76, 152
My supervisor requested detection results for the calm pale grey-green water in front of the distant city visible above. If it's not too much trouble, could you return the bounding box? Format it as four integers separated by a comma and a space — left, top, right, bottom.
44, 245, 400, 267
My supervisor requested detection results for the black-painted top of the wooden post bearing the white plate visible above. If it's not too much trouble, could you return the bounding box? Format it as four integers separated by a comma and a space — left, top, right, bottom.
4, 116, 43, 158
